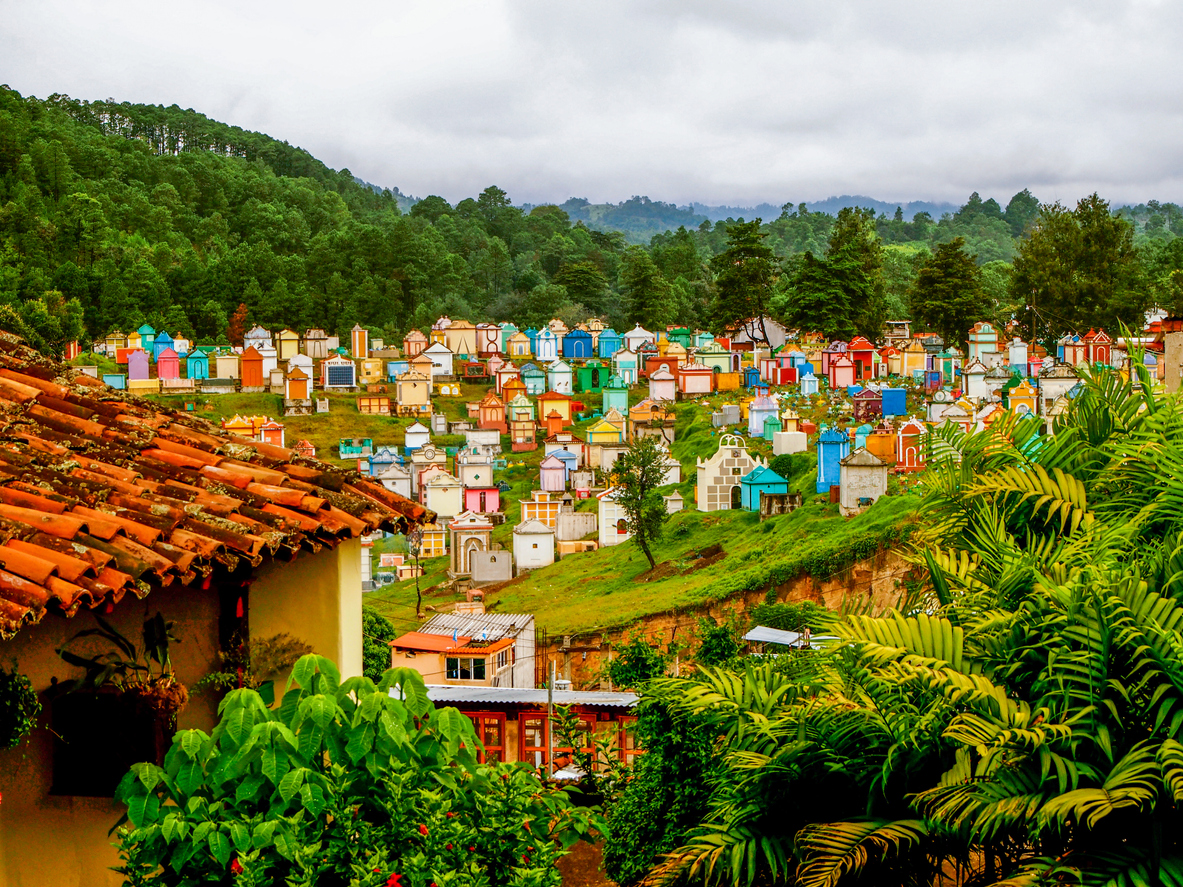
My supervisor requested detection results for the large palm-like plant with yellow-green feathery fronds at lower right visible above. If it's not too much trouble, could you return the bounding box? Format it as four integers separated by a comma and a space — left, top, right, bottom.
629, 355, 1183, 887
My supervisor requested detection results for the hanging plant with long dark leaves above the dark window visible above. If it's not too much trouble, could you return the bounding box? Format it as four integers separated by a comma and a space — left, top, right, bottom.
58, 613, 189, 727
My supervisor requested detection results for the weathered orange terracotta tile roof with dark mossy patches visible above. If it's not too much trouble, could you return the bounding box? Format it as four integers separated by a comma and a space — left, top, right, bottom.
0, 332, 435, 640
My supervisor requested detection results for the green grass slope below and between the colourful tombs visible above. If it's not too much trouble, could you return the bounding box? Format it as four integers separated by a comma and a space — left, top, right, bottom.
140, 384, 918, 634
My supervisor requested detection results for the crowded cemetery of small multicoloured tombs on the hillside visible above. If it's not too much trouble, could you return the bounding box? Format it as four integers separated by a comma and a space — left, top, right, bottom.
75, 317, 1178, 662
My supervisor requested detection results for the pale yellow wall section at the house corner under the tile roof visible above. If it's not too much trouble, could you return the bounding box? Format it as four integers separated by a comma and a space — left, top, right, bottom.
250, 539, 362, 678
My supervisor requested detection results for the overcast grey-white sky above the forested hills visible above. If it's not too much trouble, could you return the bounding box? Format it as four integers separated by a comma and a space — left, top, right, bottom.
0, 0, 1183, 205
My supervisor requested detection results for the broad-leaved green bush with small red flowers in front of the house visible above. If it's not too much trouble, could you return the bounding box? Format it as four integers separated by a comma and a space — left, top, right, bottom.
117, 655, 593, 887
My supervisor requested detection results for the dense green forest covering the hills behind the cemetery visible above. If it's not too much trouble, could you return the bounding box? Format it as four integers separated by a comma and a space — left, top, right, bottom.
0, 88, 1183, 350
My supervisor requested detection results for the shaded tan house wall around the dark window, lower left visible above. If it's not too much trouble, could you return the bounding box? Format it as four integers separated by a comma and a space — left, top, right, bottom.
0, 585, 222, 887
